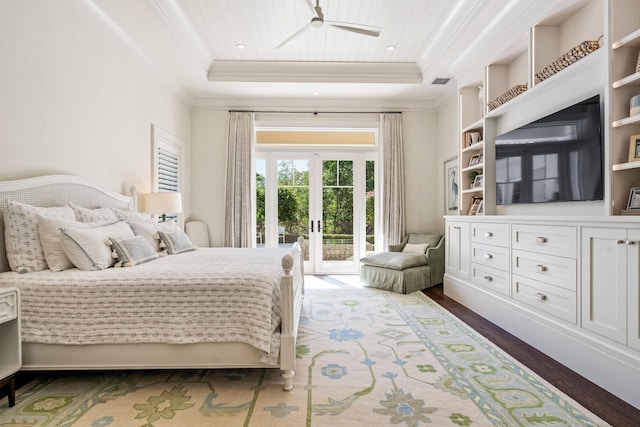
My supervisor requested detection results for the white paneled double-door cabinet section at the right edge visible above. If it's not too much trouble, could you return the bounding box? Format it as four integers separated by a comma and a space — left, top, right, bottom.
582, 227, 640, 348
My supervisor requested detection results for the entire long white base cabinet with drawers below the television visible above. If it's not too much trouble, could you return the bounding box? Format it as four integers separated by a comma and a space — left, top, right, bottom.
444, 215, 640, 408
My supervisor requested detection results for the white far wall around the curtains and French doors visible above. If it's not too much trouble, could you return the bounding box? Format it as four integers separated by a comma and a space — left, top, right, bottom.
191, 107, 443, 246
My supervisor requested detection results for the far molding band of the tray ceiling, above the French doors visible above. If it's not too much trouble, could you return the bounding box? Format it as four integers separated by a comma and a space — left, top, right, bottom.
207, 61, 422, 84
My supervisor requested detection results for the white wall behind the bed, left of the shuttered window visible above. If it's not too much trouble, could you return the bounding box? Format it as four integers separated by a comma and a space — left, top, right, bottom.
0, 0, 190, 205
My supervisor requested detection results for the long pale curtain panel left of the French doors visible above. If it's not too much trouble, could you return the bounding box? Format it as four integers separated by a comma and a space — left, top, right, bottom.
224, 111, 255, 248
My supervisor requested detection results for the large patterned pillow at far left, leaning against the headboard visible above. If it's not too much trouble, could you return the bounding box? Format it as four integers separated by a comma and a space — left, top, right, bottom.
4, 199, 75, 273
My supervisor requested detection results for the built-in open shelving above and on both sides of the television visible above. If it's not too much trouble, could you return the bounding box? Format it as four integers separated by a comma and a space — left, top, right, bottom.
459, 0, 624, 215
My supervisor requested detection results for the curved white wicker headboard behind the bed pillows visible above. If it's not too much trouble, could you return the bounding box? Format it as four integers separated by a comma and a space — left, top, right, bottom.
0, 175, 134, 272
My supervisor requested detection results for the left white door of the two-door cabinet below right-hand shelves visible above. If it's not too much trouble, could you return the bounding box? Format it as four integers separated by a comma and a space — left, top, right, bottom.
581, 228, 627, 344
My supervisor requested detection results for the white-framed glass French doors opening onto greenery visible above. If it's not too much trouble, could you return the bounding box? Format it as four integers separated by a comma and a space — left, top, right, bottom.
256, 152, 375, 273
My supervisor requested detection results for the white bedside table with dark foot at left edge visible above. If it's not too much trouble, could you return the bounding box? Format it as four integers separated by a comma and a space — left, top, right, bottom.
0, 288, 22, 407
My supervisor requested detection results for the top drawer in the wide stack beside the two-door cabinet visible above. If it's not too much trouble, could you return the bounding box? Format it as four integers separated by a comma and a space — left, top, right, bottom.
512, 224, 578, 258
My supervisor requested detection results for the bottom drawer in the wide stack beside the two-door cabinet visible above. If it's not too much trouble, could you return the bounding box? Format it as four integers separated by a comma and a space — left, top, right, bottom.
512, 274, 578, 324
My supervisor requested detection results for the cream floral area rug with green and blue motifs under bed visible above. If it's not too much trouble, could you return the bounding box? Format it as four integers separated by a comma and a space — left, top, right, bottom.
0, 278, 607, 427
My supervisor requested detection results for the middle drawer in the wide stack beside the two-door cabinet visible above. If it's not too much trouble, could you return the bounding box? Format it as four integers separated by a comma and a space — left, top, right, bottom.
512, 250, 577, 292
